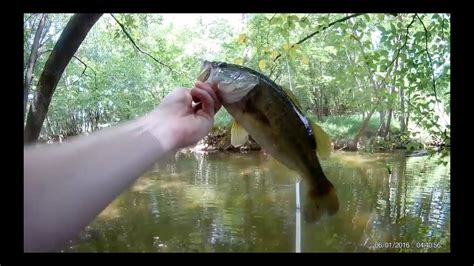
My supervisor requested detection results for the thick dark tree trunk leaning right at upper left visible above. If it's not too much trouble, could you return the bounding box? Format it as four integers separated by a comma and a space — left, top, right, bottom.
24, 13, 102, 143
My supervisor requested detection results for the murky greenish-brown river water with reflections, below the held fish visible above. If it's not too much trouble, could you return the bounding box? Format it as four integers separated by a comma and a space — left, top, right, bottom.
64, 152, 450, 252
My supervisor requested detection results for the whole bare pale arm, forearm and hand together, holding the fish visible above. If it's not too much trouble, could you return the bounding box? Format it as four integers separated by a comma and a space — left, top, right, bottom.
24, 81, 221, 252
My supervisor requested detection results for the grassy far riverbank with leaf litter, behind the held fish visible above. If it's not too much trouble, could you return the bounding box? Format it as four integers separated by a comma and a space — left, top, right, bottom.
204, 111, 449, 155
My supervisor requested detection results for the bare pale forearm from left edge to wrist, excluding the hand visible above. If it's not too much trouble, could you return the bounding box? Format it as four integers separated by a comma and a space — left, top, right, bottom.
24, 114, 173, 251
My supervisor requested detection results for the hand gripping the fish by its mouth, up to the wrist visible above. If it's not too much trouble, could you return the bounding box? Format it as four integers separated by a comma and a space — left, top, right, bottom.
143, 81, 221, 150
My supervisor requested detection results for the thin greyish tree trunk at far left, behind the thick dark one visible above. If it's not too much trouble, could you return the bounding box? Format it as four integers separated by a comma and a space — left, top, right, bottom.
23, 14, 46, 119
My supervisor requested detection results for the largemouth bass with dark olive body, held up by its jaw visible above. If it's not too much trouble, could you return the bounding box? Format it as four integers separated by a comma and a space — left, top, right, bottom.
198, 61, 339, 222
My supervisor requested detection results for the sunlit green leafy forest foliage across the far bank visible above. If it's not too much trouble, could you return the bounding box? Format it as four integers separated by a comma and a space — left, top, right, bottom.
24, 14, 450, 157
